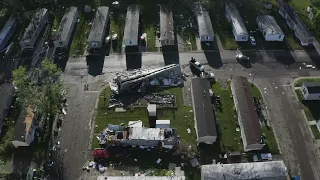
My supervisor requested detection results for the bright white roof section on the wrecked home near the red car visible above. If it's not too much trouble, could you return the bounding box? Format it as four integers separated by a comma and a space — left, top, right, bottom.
129, 127, 164, 140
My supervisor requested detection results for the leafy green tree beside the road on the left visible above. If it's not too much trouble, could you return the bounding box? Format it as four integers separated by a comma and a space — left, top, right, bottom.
13, 59, 63, 115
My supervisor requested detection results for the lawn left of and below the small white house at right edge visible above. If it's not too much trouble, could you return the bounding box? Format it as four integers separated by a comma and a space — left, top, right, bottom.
295, 89, 320, 121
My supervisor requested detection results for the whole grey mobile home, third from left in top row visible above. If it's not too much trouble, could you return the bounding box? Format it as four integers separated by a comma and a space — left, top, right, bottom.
53, 7, 78, 48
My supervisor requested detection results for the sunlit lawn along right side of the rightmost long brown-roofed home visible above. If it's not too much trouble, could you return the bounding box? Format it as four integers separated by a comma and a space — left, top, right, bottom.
251, 84, 279, 154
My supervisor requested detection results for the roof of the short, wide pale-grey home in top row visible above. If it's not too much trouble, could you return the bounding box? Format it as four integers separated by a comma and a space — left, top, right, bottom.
257, 15, 284, 35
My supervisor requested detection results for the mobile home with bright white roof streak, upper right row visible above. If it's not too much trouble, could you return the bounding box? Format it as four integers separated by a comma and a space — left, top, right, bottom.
225, 3, 249, 41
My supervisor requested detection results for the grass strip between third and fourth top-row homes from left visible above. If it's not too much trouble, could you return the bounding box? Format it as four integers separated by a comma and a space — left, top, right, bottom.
69, 11, 93, 56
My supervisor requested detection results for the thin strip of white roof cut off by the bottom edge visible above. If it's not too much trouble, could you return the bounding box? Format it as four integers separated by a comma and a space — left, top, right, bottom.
97, 176, 186, 180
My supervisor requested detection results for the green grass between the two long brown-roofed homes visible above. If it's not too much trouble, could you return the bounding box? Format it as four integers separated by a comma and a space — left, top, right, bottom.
212, 82, 243, 152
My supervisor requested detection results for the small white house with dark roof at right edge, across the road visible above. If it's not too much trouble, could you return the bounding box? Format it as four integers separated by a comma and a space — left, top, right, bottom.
300, 82, 320, 100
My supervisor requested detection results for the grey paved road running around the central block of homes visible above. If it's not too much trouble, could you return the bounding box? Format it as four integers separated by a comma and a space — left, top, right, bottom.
57, 51, 320, 180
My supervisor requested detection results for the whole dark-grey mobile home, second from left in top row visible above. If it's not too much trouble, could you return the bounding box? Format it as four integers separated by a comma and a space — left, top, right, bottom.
19, 8, 49, 50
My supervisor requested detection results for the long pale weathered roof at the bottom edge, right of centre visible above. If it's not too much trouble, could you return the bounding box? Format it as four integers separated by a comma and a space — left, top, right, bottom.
201, 161, 287, 180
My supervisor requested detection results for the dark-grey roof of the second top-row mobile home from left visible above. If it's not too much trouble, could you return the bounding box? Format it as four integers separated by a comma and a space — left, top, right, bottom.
21, 8, 48, 41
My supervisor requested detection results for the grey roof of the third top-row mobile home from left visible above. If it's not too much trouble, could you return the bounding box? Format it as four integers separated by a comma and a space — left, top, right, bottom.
55, 7, 78, 41
